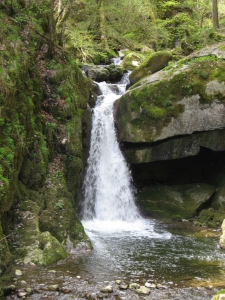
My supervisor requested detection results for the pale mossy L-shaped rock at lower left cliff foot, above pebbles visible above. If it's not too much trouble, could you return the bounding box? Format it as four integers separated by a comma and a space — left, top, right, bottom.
11, 200, 67, 265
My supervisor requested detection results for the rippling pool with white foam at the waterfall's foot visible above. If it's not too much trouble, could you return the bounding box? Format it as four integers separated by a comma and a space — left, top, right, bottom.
79, 219, 225, 286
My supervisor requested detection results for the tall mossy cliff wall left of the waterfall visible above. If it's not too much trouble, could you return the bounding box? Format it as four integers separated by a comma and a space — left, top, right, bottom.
0, 3, 91, 278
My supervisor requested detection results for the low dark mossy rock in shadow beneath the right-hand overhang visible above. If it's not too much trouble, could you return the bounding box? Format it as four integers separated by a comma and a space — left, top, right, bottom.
137, 184, 215, 220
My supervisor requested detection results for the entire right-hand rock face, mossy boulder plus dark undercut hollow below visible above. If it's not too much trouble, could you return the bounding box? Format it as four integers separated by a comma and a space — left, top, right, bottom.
115, 43, 225, 221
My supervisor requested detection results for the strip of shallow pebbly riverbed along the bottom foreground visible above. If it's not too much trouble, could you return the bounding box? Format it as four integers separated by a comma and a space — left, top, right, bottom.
4, 265, 219, 300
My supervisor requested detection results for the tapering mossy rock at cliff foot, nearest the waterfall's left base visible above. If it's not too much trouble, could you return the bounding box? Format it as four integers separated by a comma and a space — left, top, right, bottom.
39, 172, 90, 247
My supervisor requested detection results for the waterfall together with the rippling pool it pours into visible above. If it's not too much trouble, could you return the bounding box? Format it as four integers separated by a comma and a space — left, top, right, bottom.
78, 69, 225, 299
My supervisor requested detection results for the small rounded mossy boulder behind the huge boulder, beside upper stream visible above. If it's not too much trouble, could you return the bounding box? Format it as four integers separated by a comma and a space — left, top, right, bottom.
129, 51, 172, 85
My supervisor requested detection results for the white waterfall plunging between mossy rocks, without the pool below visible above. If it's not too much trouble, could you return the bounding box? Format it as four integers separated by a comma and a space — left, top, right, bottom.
82, 74, 140, 223
